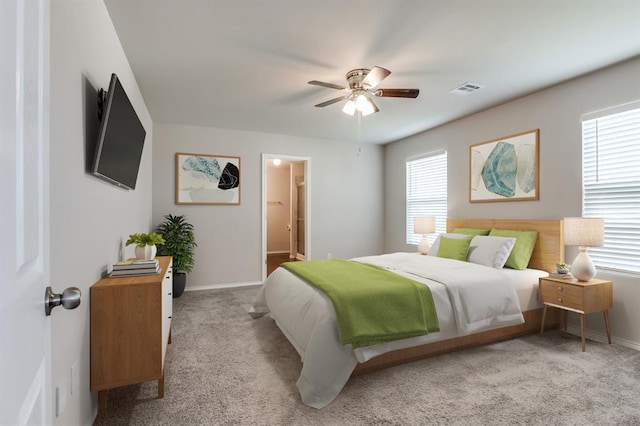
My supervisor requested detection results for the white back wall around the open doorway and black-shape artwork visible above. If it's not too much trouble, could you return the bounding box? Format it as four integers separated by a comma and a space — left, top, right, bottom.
153, 123, 383, 288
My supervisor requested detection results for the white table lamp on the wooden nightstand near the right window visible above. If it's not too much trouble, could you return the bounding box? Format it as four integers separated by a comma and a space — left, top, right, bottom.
564, 217, 604, 281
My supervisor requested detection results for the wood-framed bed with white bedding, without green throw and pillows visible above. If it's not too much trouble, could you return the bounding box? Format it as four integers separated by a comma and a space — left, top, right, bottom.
250, 219, 564, 408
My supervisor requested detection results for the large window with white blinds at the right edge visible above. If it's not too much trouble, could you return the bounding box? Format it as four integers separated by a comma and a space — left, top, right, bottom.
582, 102, 640, 273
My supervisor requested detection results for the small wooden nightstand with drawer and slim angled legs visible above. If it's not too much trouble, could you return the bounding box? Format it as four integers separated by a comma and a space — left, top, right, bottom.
538, 278, 613, 352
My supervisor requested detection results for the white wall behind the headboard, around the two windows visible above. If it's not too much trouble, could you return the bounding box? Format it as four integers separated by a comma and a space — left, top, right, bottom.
384, 58, 640, 349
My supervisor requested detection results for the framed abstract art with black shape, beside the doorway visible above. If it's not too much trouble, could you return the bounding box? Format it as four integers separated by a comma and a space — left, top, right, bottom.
176, 152, 240, 205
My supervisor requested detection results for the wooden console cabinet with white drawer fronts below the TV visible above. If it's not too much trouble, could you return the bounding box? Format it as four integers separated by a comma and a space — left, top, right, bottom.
90, 256, 173, 408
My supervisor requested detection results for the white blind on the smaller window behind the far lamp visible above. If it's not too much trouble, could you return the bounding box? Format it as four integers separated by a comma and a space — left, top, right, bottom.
407, 151, 447, 245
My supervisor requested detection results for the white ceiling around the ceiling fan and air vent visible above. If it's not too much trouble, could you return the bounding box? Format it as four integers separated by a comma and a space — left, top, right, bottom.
104, 0, 640, 143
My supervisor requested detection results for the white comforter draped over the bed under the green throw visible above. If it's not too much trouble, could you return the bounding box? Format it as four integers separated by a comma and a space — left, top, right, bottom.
250, 253, 524, 408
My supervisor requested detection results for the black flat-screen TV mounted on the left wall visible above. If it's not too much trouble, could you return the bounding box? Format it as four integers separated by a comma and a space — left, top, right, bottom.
92, 74, 147, 189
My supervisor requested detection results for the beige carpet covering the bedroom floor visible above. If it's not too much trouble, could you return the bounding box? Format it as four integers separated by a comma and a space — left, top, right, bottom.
95, 287, 640, 425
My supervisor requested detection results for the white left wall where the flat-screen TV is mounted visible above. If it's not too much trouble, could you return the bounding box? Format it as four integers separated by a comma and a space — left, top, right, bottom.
50, 0, 153, 425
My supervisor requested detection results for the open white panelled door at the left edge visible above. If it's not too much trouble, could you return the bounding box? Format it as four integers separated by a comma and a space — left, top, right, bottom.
0, 0, 52, 425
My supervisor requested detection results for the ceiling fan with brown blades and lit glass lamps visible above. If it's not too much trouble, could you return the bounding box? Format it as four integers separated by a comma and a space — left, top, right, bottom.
309, 66, 420, 116
